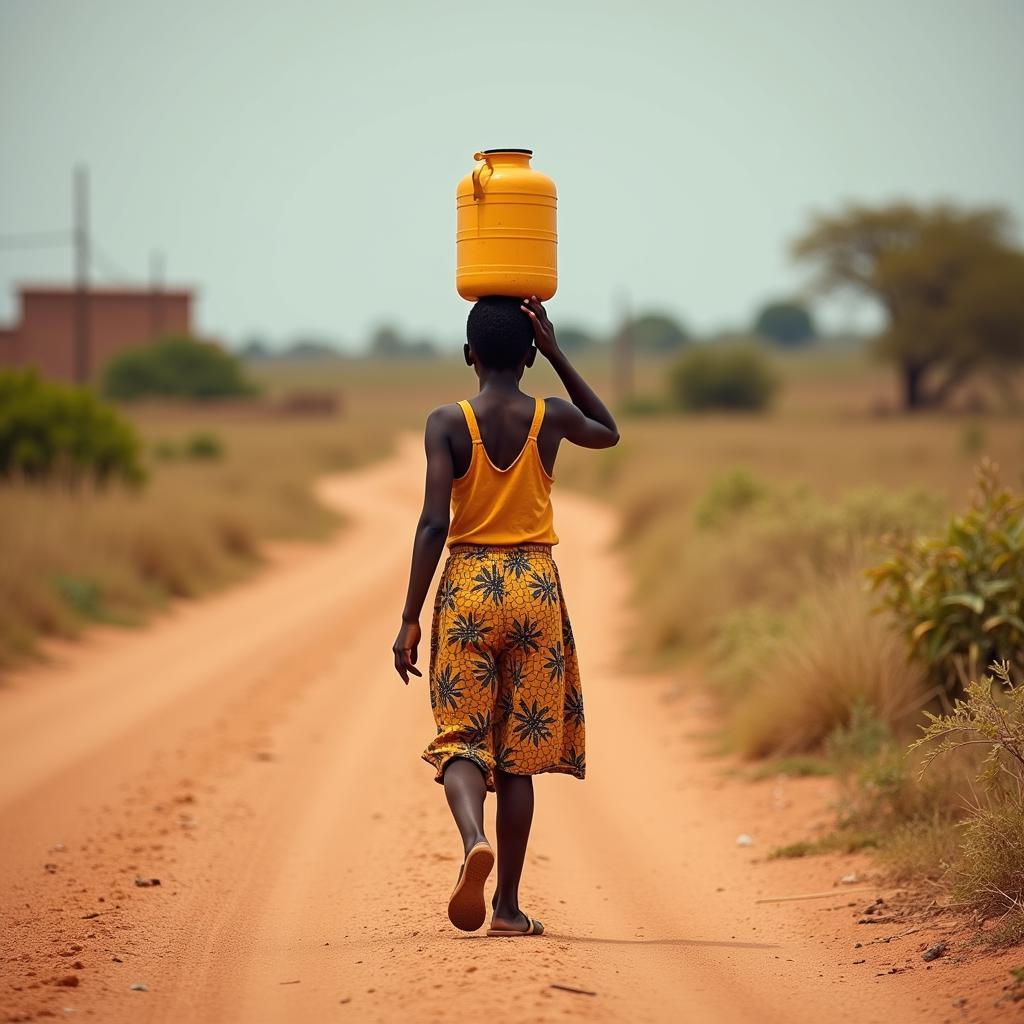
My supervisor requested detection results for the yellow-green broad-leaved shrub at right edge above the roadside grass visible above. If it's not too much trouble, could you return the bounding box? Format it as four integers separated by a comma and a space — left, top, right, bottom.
867, 459, 1024, 693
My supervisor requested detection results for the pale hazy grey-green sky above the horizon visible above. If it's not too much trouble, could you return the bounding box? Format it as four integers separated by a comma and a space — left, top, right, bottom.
0, 0, 1024, 342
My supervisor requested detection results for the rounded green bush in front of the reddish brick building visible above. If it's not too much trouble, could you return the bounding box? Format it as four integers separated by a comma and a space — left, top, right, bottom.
102, 336, 255, 401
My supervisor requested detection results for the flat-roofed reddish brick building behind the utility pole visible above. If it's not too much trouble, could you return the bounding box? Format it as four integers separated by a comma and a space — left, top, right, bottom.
0, 286, 193, 381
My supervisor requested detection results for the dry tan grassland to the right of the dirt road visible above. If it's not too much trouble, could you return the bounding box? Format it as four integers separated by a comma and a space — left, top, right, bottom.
560, 360, 1024, 942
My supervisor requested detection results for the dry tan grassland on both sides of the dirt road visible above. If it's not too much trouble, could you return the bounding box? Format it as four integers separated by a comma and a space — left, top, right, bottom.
0, 350, 1024, 942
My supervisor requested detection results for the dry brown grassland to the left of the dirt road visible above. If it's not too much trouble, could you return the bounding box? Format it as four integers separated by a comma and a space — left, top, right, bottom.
0, 406, 391, 667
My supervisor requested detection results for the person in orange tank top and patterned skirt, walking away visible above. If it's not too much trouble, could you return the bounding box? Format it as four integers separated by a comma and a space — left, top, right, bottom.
393, 296, 618, 936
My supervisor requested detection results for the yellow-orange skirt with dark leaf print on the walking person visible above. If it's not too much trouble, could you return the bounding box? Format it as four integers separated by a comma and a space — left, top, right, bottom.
423, 544, 586, 790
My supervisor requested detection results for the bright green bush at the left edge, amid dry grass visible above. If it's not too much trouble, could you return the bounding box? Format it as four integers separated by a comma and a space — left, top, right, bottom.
0, 370, 144, 484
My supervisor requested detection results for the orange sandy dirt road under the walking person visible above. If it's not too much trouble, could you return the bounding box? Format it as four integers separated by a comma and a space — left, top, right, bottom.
0, 441, 1007, 1024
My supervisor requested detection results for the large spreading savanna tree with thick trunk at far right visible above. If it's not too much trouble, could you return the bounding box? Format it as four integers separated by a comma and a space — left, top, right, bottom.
794, 204, 1024, 410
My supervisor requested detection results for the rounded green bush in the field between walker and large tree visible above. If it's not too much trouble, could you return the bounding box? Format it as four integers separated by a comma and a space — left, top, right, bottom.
669, 345, 778, 412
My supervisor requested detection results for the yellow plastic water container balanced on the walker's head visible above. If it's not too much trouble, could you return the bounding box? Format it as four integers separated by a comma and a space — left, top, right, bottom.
455, 150, 558, 302
